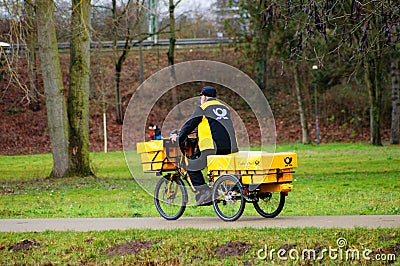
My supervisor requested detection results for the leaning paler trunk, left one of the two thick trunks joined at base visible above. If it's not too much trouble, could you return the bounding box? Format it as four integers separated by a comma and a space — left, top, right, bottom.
36, 0, 69, 177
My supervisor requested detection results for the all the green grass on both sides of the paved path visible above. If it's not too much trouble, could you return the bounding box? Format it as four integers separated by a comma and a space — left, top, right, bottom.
0, 144, 400, 265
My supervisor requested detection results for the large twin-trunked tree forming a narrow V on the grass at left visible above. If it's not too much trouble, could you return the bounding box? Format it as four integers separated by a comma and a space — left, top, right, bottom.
36, 0, 93, 177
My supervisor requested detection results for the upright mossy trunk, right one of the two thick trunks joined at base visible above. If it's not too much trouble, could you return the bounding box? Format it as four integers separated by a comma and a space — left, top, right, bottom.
68, 0, 93, 176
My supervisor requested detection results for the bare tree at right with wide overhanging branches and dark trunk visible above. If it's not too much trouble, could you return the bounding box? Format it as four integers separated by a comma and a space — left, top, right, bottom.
260, 0, 400, 146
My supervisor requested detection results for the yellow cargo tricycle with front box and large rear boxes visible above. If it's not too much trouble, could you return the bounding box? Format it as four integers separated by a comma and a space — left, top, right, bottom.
137, 133, 297, 221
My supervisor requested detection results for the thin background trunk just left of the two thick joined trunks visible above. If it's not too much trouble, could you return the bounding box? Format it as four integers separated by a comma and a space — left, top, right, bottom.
24, 0, 41, 112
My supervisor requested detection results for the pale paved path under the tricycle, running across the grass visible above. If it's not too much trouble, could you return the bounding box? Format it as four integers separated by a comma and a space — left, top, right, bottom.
0, 215, 400, 232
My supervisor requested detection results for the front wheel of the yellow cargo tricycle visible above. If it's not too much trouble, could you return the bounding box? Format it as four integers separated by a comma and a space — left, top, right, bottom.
154, 177, 188, 220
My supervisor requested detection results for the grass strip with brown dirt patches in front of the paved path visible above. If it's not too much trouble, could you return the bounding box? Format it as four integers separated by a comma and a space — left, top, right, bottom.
0, 228, 400, 265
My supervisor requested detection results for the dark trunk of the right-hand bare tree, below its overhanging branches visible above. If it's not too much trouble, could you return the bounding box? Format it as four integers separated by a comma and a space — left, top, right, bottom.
364, 56, 382, 146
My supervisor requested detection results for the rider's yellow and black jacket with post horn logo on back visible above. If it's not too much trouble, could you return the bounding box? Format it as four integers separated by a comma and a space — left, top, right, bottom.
179, 98, 238, 154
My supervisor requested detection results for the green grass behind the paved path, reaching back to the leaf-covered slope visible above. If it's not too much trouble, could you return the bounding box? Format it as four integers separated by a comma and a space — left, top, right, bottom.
0, 144, 400, 218
